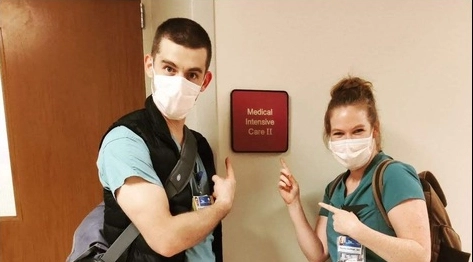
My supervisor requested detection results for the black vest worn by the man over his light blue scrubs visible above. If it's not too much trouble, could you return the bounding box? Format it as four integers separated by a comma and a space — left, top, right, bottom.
101, 96, 223, 262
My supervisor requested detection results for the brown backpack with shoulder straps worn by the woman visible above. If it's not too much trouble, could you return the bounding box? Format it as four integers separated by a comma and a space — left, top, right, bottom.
329, 159, 471, 262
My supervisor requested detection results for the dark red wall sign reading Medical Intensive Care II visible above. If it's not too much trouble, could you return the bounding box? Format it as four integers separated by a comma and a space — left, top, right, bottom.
231, 89, 289, 152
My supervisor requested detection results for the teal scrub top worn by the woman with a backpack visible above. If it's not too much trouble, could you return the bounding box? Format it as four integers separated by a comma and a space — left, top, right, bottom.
319, 152, 425, 262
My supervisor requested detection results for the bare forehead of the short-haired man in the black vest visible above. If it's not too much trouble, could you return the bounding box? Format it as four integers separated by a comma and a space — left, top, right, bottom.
156, 38, 207, 72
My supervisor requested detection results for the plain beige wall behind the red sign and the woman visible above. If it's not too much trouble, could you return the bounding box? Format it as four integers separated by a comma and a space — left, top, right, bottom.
143, 0, 472, 262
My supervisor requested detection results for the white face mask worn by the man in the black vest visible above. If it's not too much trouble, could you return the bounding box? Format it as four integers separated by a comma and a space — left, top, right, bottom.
151, 74, 200, 120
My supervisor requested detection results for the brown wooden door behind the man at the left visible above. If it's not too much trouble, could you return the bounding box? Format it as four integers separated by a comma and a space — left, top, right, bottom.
0, 0, 145, 262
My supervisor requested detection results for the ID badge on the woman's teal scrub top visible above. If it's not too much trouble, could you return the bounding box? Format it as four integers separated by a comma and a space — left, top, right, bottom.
337, 236, 366, 262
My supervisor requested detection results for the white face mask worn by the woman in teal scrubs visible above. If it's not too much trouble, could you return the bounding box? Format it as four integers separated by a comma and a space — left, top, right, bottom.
328, 134, 374, 170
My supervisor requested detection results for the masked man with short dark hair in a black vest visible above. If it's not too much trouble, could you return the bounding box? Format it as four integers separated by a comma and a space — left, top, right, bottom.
97, 18, 236, 262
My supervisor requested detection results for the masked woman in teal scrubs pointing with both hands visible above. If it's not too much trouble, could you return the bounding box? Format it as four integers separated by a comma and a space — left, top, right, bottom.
279, 77, 430, 262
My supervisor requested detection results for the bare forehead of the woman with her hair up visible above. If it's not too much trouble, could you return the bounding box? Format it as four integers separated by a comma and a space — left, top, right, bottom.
330, 105, 370, 130
